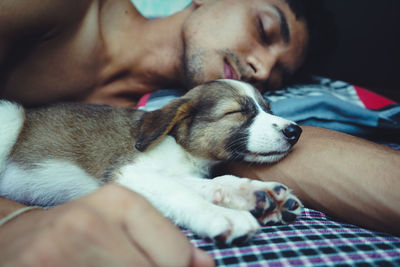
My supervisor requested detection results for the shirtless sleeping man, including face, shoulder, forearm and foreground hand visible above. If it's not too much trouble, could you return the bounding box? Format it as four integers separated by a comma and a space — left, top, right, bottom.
0, 0, 400, 266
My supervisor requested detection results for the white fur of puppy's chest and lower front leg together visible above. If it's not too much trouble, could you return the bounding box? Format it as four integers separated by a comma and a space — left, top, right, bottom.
116, 136, 260, 243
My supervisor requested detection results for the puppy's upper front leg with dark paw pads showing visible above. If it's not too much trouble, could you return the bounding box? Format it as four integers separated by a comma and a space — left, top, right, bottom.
177, 175, 303, 225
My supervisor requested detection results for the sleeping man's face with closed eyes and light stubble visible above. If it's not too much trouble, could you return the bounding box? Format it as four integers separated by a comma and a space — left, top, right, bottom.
183, 0, 308, 90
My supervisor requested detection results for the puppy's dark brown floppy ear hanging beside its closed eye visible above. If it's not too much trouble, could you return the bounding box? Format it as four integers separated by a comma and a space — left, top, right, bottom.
135, 98, 193, 152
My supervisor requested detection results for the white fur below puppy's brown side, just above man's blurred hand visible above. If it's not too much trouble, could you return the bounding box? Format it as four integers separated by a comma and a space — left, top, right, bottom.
0, 160, 99, 207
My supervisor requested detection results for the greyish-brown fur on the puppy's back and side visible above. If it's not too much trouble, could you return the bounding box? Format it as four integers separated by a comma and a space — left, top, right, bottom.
11, 104, 143, 178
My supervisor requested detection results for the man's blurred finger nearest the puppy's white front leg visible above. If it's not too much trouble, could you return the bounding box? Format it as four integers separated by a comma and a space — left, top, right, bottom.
79, 185, 213, 266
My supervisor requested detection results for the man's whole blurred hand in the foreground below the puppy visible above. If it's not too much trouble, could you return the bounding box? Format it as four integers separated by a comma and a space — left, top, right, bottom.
0, 185, 214, 267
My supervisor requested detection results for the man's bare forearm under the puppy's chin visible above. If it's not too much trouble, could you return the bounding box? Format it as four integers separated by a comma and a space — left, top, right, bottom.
220, 126, 400, 235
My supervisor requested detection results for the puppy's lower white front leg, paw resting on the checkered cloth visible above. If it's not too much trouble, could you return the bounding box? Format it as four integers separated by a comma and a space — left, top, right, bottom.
116, 168, 260, 243
